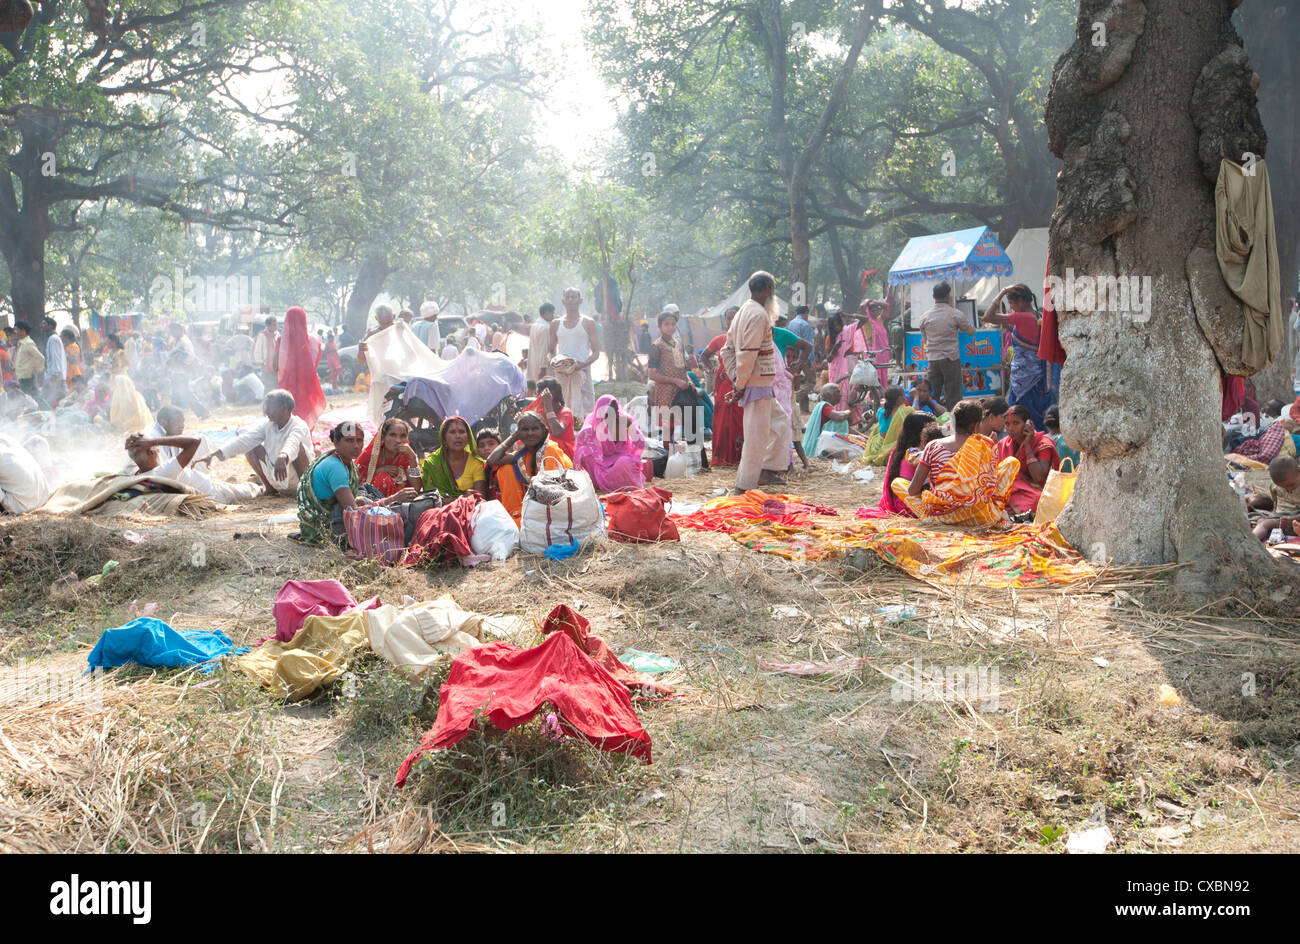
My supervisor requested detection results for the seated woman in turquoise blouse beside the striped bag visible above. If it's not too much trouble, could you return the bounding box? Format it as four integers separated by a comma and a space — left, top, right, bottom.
291, 421, 416, 549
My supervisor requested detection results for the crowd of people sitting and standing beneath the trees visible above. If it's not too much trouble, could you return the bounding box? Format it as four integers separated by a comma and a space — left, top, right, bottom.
10, 272, 1300, 566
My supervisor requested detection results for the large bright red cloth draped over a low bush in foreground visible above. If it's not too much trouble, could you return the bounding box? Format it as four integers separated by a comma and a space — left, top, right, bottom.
397, 632, 650, 787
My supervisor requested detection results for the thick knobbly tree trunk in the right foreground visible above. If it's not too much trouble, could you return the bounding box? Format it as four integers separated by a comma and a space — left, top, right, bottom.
1047, 0, 1278, 593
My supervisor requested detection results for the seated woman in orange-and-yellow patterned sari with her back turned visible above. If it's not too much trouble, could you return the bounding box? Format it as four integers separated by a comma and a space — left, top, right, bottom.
889, 400, 1021, 527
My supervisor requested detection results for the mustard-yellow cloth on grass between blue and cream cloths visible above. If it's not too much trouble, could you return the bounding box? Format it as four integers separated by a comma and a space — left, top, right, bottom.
234, 611, 367, 701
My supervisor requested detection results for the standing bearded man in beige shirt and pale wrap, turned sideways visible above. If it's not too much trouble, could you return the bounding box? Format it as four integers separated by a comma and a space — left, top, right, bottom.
722, 272, 792, 494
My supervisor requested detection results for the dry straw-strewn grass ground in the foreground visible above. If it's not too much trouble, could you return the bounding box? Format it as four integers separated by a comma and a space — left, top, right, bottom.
0, 395, 1300, 852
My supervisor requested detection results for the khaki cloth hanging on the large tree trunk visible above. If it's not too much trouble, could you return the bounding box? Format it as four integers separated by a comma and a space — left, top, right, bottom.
1214, 160, 1284, 371
